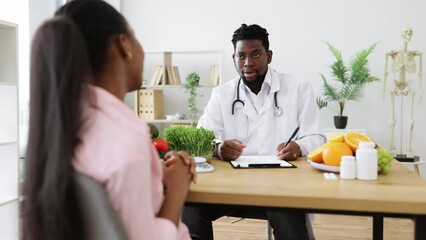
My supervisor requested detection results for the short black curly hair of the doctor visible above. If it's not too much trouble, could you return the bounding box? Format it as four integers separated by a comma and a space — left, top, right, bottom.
232, 23, 269, 51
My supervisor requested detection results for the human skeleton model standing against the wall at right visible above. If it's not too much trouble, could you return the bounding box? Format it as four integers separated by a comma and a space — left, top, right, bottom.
383, 28, 423, 157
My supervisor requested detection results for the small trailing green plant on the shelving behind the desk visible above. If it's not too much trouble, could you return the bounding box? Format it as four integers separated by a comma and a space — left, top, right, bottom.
183, 72, 200, 126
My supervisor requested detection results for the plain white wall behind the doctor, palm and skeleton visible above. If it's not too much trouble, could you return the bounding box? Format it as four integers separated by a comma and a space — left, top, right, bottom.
121, 0, 426, 176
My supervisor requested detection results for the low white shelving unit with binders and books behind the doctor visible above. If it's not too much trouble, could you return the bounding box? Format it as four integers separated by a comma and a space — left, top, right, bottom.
135, 50, 222, 129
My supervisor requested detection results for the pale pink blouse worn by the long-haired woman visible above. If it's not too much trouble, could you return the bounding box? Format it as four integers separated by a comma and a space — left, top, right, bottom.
73, 86, 191, 240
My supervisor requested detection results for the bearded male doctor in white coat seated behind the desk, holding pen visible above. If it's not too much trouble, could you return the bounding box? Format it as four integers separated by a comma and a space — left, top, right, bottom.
182, 24, 325, 240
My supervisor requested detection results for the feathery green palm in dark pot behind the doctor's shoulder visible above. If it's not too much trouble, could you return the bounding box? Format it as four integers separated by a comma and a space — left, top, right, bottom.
317, 43, 379, 129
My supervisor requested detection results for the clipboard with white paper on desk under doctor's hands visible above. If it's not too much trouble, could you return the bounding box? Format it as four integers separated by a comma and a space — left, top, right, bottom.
229, 155, 296, 169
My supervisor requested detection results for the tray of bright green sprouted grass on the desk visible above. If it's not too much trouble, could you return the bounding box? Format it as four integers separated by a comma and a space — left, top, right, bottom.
160, 125, 215, 158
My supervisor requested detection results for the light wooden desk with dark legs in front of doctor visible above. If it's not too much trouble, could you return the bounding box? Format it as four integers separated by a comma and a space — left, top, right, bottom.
187, 158, 426, 239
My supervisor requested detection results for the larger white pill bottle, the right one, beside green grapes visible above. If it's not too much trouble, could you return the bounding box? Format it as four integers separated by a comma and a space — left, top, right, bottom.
355, 142, 378, 180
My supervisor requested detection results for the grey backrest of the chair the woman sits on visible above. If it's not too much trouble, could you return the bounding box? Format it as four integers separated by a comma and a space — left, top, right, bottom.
74, 172, 127, 240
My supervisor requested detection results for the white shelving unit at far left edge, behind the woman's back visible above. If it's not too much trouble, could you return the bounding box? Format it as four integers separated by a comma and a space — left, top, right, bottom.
0, 20, 19, 239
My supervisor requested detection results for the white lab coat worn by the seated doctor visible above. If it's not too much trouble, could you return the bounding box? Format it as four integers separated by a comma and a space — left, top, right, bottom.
198, 67, 326, 156
